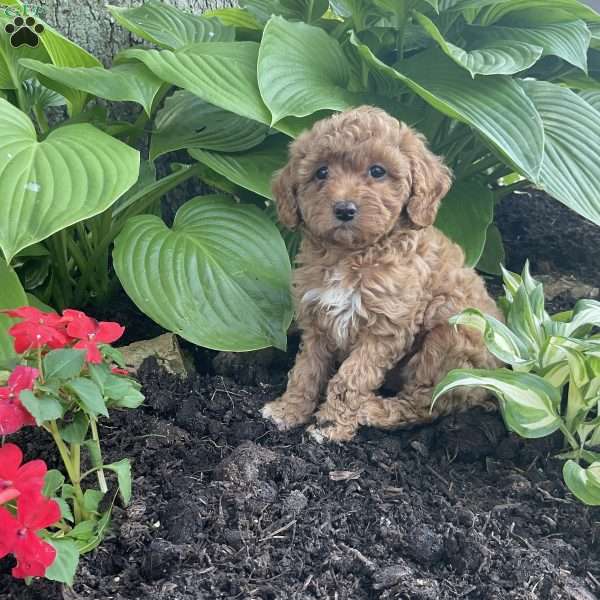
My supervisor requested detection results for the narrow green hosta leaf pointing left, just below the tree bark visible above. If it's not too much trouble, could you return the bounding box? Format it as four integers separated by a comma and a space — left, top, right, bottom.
21, 59, 163, 115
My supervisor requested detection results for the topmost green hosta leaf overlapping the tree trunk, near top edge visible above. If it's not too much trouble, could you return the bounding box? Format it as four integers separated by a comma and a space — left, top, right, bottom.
108, 0, 235, 50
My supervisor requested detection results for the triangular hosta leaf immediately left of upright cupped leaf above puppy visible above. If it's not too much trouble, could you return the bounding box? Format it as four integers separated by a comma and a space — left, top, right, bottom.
119, 42, 271, 124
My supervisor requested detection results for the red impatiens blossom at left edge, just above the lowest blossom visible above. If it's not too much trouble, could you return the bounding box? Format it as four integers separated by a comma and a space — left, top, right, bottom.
0, 444, 47, 504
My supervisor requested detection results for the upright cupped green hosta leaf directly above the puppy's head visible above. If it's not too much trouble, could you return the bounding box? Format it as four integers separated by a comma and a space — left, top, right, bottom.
258, 17, 359, 123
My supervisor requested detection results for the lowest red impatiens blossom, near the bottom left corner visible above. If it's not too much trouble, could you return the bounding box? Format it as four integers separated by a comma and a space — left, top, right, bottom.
0, 493, 60, 578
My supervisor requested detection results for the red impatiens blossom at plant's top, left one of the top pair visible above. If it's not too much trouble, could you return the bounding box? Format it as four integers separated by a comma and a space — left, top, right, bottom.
5, 306, 69, 354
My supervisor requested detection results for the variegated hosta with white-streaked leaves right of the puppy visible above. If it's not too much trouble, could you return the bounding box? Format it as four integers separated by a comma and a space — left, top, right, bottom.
433, 265, 600, 505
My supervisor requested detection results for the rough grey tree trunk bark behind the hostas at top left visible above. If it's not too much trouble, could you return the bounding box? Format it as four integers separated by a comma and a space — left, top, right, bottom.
35, 0, 233, 65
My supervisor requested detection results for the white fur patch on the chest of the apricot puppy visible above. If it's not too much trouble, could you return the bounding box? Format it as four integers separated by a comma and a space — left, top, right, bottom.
301, 271, 363, 347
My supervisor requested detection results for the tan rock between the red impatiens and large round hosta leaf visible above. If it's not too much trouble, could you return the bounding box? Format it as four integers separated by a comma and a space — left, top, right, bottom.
119, 333, 195, 378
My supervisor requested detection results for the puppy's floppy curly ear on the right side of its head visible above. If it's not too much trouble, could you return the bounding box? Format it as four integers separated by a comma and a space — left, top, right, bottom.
401, 126, 452, 227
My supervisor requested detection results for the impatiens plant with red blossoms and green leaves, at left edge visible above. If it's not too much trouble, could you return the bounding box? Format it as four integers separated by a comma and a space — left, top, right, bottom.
0, 306, 144, 584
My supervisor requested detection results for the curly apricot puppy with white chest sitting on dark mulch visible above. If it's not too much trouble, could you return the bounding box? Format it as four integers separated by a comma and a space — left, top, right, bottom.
262, 106, 500, 441
